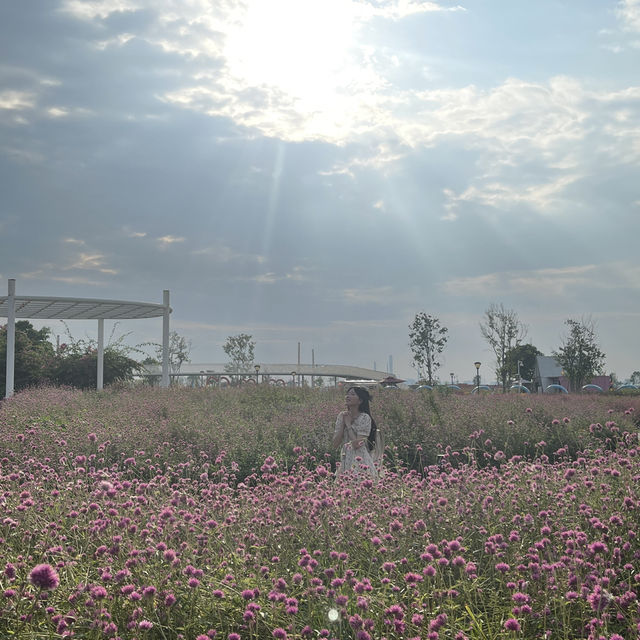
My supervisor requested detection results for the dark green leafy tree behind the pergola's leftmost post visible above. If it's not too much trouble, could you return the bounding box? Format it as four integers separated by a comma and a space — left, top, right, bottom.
0, 320, 55, 396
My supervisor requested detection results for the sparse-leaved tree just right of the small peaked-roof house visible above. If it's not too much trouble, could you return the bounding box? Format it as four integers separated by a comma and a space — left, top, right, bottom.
553, 318, 605, 391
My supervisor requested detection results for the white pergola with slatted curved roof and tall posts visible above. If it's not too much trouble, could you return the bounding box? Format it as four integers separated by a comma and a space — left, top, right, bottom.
0, 279, 171, 398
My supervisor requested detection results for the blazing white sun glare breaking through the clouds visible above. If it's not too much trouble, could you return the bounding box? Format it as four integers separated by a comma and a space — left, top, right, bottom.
224, 0, 358, 109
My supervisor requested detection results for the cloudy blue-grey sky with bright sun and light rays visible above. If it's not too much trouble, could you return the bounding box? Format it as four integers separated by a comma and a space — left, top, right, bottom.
0, 0, 640, 381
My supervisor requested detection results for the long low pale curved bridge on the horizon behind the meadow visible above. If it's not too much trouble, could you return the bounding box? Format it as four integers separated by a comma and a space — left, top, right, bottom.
139, 362, 392, 385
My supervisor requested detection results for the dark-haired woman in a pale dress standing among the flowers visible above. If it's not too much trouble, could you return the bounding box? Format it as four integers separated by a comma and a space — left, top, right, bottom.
333, 387, 381, 479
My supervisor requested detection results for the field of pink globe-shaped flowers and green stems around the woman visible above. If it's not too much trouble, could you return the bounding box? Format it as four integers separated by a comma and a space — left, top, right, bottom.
0, 386, 640, 640
